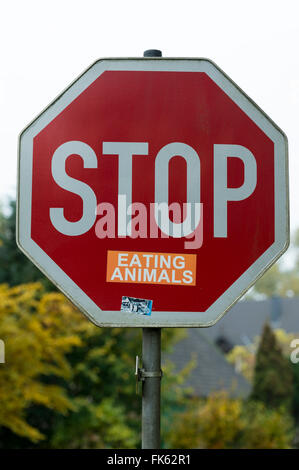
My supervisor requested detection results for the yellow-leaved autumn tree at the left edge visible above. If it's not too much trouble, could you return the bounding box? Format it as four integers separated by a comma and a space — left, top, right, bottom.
0, 284, 80, 442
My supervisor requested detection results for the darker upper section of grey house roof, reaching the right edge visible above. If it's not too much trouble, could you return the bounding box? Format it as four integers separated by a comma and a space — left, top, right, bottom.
202, 297, 299, 346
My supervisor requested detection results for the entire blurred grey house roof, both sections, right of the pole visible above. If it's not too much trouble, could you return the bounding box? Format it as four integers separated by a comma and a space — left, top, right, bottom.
163, 297, 299, 397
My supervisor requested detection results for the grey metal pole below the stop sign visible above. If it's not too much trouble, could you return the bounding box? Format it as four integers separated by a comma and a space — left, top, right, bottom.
142, 328, 161, 449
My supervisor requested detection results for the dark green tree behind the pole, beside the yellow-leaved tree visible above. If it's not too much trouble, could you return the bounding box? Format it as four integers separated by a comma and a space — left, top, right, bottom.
45, 327, 185, 448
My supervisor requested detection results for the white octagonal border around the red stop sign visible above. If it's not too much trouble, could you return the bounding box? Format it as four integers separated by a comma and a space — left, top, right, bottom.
17, 58, 289, 328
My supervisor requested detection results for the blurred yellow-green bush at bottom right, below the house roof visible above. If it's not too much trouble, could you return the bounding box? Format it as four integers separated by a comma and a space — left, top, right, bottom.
167, 392, 293, 449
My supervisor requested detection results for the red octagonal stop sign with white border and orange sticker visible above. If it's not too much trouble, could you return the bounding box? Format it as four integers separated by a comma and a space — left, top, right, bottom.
18, 58, 289, 327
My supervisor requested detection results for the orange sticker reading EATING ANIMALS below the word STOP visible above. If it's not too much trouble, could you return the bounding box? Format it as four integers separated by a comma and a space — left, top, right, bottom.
106, 250, 196, 286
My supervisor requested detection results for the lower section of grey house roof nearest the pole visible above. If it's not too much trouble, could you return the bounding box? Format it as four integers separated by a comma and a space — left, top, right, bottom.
167, 328, 250, 397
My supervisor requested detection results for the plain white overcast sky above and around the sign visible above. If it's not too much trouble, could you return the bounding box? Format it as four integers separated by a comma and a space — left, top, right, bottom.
0, 0, 299, 239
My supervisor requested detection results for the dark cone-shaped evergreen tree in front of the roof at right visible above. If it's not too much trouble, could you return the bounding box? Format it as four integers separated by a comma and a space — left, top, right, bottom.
251, 323, 293, 409
